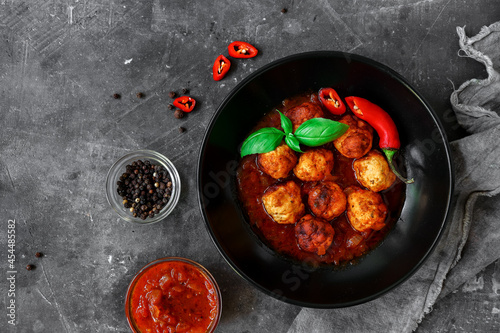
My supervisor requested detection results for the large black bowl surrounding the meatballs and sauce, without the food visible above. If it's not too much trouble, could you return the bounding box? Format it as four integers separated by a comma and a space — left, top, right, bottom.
198, 51, 453, 308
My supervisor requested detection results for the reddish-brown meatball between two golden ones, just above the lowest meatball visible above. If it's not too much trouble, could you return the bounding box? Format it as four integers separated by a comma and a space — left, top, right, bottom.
307, 181, 347, 220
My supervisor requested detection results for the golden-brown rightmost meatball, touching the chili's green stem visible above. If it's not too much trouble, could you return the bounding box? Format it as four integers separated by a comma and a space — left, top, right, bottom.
352, 150, 396, 192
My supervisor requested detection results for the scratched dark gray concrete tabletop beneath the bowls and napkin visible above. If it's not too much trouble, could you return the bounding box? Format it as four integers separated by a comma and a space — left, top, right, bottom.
0, 0, 500, 333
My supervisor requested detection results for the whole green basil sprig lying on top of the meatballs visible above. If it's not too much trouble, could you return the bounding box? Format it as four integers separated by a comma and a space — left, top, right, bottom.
241, 110, 349, 157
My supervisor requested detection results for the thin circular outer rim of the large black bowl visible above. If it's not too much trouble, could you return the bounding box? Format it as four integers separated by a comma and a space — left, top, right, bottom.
196, 50, 455, 309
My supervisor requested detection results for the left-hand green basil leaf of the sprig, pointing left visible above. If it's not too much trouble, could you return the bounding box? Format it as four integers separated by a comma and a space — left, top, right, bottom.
241, 127, 285, 157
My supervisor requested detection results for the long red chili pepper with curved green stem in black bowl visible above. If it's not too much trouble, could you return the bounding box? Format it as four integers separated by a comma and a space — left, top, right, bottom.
345, 96, 415, 184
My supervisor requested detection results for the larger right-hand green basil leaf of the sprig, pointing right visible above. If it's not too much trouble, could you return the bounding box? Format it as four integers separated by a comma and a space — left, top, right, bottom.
294, 118, 349, 147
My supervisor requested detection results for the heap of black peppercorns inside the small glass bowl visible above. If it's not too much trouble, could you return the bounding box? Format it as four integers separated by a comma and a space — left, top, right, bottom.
117, 160, 172, 220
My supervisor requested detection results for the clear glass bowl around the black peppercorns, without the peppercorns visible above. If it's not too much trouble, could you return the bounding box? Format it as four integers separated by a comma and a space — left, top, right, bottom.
106, 150, 181, 224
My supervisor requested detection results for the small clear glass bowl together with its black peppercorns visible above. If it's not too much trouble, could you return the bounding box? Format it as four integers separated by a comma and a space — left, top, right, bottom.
106, 150, 181, 224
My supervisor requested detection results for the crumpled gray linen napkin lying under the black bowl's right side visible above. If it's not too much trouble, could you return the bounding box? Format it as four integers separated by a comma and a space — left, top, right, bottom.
288, 22, 500, 333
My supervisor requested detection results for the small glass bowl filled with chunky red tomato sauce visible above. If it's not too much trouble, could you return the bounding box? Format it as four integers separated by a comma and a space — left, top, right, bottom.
125, 258, 222, 333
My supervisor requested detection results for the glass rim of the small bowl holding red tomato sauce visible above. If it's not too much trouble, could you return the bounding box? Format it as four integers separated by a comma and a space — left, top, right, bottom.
125, 257, 222, 333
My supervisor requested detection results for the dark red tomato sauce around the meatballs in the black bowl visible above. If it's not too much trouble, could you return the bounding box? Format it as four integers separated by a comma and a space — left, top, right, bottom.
237, 94, 405, 265
